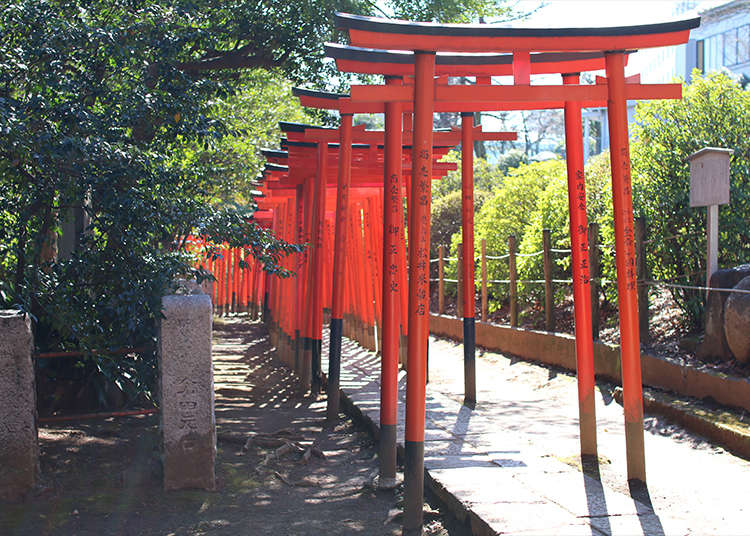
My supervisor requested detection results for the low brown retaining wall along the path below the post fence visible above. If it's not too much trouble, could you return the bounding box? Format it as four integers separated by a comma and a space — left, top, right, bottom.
430, 315, 750, 411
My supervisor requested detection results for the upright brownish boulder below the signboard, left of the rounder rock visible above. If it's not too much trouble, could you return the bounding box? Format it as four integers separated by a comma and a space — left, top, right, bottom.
696, 264, 750, 361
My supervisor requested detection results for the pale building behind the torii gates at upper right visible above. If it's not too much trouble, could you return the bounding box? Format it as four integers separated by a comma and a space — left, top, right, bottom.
583, 0, 750, 160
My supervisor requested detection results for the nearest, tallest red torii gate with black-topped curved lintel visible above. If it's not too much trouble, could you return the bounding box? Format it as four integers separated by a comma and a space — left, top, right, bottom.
337, 14, 700, 534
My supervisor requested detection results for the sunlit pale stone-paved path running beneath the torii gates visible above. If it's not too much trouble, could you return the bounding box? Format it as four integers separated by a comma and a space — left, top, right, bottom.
323, 328, 750, 536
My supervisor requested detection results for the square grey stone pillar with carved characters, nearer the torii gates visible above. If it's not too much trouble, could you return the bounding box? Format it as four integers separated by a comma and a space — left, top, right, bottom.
159, 294, 216, 490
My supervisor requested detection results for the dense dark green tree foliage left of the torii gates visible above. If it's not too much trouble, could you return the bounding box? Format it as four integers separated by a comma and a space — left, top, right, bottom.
0, 0, 548, 406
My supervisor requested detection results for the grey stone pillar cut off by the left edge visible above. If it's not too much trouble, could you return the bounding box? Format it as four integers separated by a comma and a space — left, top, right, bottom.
0, 310, 39, 500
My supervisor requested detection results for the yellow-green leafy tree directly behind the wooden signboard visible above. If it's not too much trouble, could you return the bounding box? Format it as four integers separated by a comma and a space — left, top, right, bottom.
631, 72, 750, 328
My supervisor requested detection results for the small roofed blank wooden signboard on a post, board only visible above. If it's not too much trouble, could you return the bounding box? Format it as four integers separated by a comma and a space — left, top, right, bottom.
688, 147, 734, 207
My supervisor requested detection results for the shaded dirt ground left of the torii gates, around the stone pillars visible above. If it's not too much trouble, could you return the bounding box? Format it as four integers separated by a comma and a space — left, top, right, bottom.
0, 319, 465, 536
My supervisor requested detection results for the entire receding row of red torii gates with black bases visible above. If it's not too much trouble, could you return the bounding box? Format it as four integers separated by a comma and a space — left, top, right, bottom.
238, 14, 700, 534
